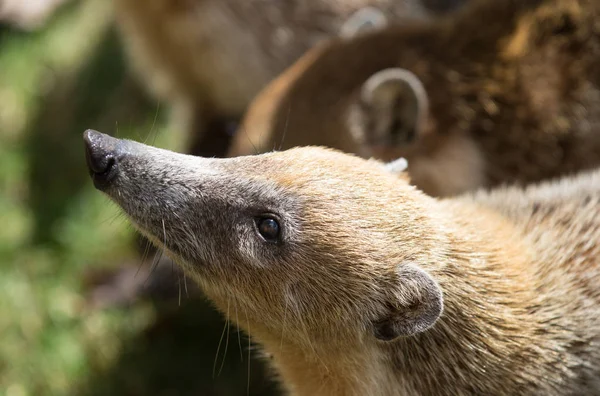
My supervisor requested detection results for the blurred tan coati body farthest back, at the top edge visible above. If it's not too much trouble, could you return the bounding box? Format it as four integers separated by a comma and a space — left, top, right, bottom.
114, 0, 466, 155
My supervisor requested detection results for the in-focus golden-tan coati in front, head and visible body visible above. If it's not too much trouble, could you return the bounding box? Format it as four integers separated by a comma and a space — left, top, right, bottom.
86, 132, 600, 396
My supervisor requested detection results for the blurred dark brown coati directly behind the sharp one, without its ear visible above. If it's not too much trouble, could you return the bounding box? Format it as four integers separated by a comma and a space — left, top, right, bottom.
229, 0, 600, 195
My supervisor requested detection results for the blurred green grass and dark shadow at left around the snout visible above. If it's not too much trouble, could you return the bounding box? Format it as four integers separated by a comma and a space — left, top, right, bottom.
0, 0, 275, 396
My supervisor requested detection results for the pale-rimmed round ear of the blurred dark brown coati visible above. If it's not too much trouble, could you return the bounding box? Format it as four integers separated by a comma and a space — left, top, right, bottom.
360, 68, 429, 146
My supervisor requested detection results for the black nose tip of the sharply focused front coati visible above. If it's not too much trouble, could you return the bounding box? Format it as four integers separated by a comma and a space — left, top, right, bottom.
83, 129, 118, 188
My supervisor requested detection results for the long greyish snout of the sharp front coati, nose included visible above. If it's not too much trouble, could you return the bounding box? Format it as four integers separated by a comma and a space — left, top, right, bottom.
83, 130, 245, 268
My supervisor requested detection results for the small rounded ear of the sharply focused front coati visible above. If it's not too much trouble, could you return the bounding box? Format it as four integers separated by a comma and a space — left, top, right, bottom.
373, 264, 444, 341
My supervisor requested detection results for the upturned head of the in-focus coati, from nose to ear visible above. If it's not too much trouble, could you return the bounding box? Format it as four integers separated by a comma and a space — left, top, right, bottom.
84, 130, 443, 349
